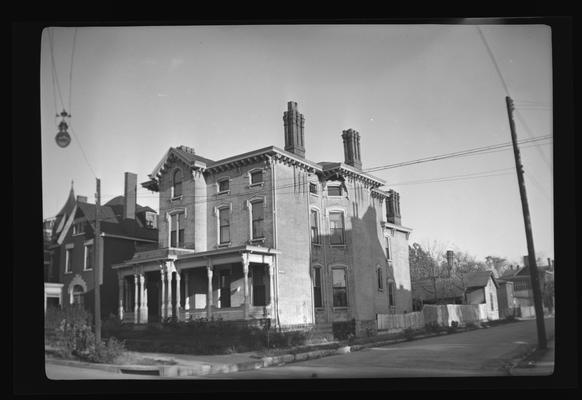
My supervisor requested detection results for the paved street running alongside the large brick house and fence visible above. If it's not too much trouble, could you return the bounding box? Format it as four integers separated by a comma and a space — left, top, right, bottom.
205, 318, 554, 379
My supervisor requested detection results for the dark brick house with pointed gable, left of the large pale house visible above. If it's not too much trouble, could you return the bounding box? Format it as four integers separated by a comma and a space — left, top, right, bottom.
45, 172, 158, 316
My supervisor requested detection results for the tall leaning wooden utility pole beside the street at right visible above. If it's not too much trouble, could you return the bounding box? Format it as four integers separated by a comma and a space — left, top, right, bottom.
505, 96, 547, 349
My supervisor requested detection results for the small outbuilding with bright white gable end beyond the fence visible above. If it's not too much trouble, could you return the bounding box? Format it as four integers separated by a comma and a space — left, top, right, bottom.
463, 271, 499, 320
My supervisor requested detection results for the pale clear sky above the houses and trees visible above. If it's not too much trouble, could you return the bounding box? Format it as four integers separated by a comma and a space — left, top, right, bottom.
40, 20, 554, 262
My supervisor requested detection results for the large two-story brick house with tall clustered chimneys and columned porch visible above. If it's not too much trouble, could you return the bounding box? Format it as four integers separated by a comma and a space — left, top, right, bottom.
114, 102, 412, 332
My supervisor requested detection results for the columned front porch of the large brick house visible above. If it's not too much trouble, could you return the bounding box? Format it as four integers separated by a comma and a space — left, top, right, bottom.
114, 246, 276, 324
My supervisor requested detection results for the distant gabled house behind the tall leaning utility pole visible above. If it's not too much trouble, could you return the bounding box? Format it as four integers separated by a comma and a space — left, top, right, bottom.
501, 263, 554, 316
